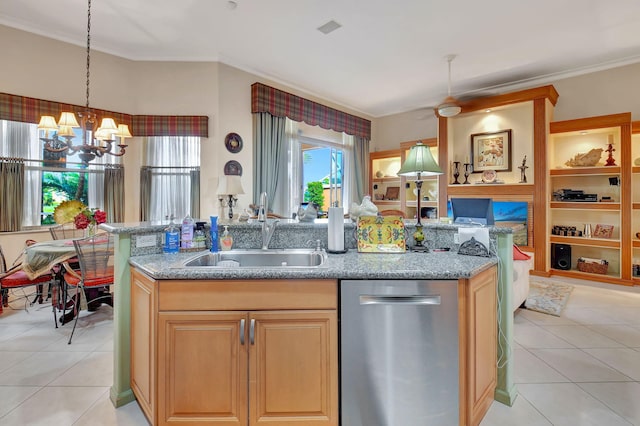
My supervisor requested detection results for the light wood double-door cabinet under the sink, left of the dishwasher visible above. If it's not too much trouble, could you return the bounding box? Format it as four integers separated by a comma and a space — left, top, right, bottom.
131, 271, 338, 426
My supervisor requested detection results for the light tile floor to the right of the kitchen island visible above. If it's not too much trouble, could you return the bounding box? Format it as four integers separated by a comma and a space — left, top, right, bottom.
481, 279, 640, 426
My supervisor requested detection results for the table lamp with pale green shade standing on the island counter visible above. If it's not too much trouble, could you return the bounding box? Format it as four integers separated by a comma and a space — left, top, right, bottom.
398, 141, 442, 251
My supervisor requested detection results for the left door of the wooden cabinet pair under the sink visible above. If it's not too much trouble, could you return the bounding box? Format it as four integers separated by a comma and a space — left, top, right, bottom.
158, 311, 248, 426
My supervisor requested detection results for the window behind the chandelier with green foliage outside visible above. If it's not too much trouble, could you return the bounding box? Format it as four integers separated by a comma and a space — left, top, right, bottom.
0, 120, 112, 228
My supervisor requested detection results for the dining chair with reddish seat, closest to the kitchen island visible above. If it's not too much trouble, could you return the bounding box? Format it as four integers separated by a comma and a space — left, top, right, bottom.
63, 233, 114, 344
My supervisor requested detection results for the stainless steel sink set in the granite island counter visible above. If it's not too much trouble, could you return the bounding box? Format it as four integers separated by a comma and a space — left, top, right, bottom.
183, 249, 327, 268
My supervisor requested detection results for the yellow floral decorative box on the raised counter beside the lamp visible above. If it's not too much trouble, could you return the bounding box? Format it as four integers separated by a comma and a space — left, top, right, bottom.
356, 216, 406, 253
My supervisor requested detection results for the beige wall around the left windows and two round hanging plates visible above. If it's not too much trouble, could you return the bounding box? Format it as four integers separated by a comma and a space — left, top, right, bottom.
0, 25, 371, 259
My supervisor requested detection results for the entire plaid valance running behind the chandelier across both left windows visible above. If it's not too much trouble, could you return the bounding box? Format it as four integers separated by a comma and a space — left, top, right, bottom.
0, 93, 209, 138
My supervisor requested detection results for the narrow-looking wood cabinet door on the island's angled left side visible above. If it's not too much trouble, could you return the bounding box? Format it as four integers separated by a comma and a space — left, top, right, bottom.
131, 270, 157, 424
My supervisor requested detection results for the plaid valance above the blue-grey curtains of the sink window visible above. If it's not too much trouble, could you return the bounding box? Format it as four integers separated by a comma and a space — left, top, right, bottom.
251, 83, 371, 140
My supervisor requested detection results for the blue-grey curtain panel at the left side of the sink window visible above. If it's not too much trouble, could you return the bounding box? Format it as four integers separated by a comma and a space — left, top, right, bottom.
253, 112, 289, 210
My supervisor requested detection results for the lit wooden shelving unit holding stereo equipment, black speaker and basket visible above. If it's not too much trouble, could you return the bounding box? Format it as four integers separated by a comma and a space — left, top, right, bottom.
546, 113, 640, 285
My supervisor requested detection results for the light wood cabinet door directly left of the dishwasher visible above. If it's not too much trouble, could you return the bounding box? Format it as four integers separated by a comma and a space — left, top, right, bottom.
249, 310, 338, 425
